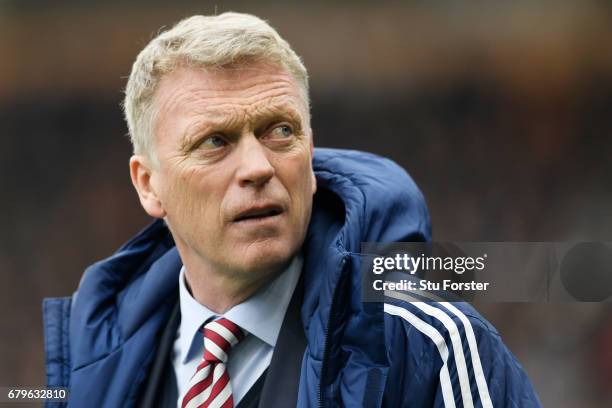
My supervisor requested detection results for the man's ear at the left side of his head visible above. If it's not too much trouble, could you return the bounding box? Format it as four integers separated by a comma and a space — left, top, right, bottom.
130, 154, 166, 218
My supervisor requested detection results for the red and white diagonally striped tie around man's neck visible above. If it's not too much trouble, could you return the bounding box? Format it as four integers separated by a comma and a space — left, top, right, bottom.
181, 318, 245, 408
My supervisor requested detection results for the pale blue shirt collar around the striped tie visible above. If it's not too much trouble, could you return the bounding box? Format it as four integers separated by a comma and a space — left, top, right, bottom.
178, 255, 302, 364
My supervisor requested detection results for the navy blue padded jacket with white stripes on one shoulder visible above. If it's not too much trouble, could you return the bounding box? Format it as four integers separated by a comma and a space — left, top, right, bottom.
43, 149, 540, 407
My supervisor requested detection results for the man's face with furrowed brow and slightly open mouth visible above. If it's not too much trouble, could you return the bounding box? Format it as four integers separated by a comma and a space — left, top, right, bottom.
143, 63, 316, 274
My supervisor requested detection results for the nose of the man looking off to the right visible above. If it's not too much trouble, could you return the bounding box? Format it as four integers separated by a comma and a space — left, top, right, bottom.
236, 134, 275, 187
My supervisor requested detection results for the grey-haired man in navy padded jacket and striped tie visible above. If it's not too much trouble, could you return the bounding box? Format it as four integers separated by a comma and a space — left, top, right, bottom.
45, 13, 539, 407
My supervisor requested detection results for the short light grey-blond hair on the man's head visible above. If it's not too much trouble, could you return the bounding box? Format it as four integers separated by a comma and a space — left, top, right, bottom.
123, 12, 310, 163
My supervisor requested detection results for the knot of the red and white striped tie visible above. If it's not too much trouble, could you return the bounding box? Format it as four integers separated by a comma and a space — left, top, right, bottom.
202, 317, 245, 363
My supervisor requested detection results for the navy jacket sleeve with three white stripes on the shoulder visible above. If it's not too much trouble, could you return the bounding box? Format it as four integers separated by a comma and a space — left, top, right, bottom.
383, 301, 541, 408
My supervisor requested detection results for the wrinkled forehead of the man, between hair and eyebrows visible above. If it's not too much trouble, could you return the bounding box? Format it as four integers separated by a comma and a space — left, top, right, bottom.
154, 62, 306, 134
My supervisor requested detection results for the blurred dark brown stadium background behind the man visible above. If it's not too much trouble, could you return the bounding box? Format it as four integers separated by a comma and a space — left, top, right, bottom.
0, 0, 612, 408
